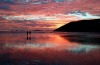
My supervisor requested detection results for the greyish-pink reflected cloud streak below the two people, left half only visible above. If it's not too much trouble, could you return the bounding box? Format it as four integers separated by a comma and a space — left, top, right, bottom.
3, 43, 55, 49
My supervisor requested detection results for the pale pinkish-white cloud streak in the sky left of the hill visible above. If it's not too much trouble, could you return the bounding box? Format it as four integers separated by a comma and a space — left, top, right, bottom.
3, 15, 59, 21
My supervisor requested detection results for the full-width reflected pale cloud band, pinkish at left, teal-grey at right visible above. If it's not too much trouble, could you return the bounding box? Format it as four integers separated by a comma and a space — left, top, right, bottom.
3, 43, 100, 53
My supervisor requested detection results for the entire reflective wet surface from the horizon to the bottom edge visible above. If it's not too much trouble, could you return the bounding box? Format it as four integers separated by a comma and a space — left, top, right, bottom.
0, 33, 100, 65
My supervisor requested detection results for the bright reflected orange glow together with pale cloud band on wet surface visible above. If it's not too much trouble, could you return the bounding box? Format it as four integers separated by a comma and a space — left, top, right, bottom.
1, 33, 100, 53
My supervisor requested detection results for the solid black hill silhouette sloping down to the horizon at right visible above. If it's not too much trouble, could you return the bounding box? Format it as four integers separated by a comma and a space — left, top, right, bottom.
54, 19, 100, 32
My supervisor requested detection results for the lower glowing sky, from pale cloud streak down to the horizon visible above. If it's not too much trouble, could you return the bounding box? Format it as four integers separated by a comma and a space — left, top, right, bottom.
0, 13, 100, 30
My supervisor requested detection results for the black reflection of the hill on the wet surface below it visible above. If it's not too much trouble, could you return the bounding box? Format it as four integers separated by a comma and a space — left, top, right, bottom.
62, 32, 100, 45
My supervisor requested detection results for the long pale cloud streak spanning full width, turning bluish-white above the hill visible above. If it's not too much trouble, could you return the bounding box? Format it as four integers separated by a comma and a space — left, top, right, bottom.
3, 13, 100, 21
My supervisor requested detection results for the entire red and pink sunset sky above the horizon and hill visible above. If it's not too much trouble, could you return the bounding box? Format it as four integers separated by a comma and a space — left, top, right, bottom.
0, 0, 100, 31
